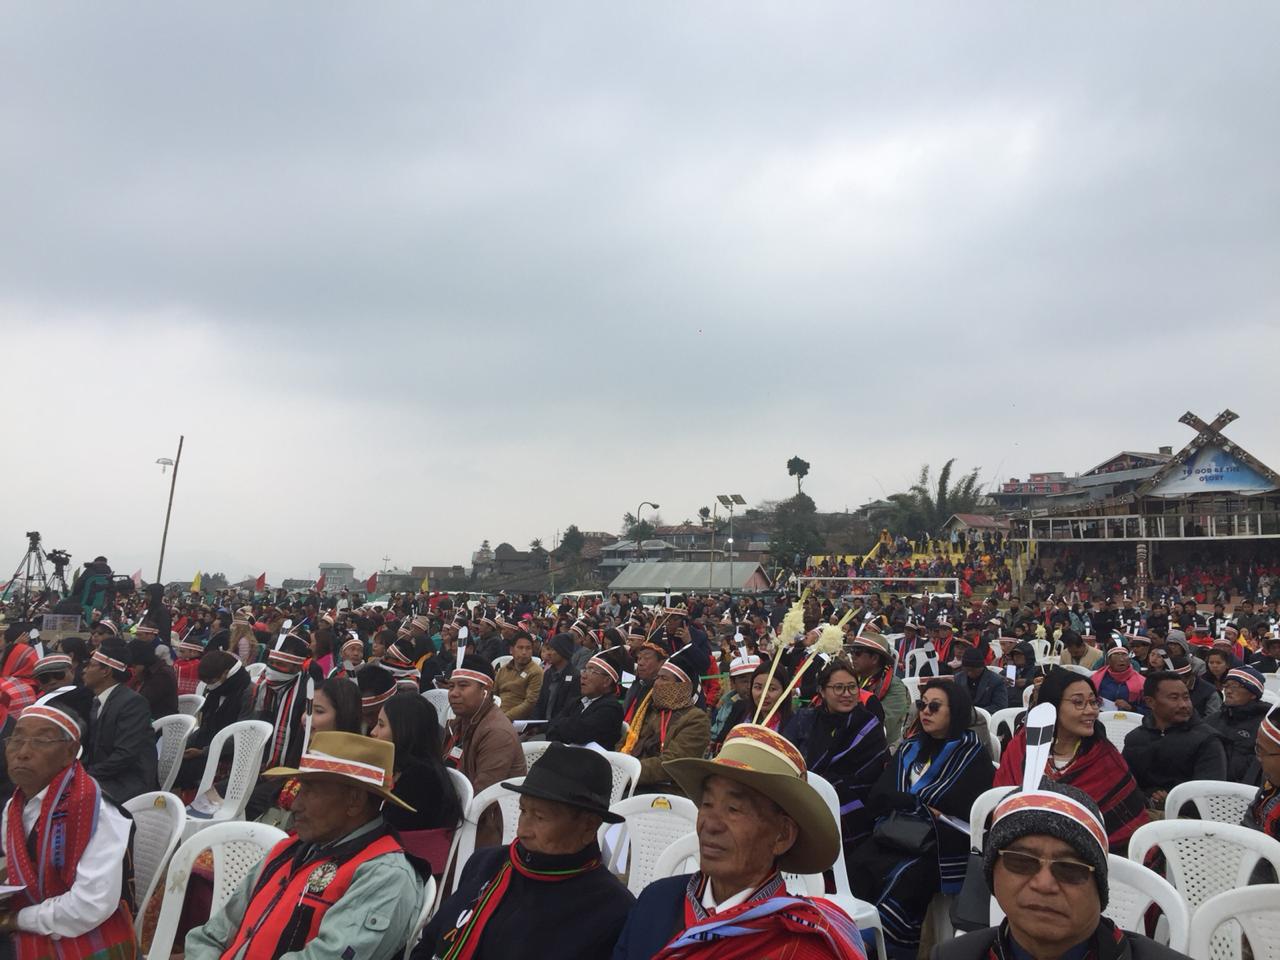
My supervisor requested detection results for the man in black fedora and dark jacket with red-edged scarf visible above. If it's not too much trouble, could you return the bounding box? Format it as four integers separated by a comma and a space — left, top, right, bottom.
413, 744, 635, 960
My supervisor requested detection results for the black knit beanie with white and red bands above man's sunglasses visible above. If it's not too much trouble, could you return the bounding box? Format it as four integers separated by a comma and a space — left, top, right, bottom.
983, 778, 1108, 910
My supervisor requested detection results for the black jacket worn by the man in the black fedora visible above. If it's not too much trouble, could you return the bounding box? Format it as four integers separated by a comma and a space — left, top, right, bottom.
412, 842, 635, 960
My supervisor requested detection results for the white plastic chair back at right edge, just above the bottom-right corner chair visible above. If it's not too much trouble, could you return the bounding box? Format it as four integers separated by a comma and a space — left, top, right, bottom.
1129, 820, 1280, 911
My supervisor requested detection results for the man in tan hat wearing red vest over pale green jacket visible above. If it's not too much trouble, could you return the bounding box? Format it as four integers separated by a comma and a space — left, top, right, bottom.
186, 732, 428, 960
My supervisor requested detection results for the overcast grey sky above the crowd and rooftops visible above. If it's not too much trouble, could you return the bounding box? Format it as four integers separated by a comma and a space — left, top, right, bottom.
0, 0, 1280, 582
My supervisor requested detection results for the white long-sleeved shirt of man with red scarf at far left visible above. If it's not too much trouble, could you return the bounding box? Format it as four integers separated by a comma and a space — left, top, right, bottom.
0, 787, 132, 937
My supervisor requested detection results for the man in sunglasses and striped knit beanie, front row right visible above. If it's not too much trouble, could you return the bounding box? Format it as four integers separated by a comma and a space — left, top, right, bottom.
932, 780, 1185, 960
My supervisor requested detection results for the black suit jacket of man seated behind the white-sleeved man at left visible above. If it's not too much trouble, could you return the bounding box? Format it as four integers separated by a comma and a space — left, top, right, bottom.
84, 684, 159, 804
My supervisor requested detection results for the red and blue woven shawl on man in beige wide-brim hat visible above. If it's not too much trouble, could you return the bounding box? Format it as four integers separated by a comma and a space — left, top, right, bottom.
655, 873, 865, 960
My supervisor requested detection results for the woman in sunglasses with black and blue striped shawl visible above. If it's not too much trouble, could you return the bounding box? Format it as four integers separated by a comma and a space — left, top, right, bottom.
849, 677, 992, 960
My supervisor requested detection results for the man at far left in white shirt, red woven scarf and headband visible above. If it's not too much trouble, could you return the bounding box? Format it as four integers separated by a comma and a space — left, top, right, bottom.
0, 696, 136, 960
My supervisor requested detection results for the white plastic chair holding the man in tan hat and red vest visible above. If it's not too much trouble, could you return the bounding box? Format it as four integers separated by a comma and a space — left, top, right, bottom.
147, 820, 288, 960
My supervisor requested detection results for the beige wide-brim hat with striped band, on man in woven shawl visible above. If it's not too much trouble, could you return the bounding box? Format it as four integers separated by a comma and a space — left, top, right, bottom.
663, 723, 840, 873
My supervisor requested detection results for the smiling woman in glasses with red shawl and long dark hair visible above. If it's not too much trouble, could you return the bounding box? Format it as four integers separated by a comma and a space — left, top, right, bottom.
993, 667, 1147, 855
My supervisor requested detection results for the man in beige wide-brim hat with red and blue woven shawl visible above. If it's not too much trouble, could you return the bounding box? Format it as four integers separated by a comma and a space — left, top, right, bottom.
613, 723, 864, 960
